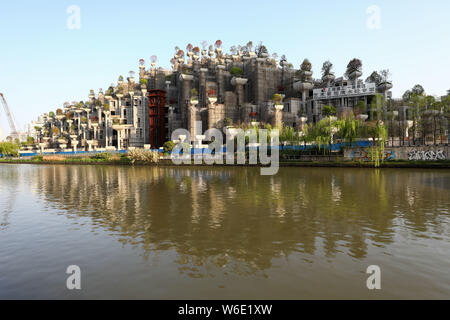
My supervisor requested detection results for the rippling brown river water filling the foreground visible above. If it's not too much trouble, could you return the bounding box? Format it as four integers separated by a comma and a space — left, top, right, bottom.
0, 165, 450, 299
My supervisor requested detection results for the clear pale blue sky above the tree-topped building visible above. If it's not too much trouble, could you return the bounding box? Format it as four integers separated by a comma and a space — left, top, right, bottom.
0, 0, 450, 134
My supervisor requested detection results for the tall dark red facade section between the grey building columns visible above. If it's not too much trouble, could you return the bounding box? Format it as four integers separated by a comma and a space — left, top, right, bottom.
148, 90, 166, 149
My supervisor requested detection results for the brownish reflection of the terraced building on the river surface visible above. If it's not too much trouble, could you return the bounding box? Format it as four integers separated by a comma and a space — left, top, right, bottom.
23, 166, 450, 277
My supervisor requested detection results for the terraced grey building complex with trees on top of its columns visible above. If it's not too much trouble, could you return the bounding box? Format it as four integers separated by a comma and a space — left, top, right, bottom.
31, 41, 392, 150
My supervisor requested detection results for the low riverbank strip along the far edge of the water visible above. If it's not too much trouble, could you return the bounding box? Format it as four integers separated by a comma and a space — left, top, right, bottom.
0, 156, 450, 169
